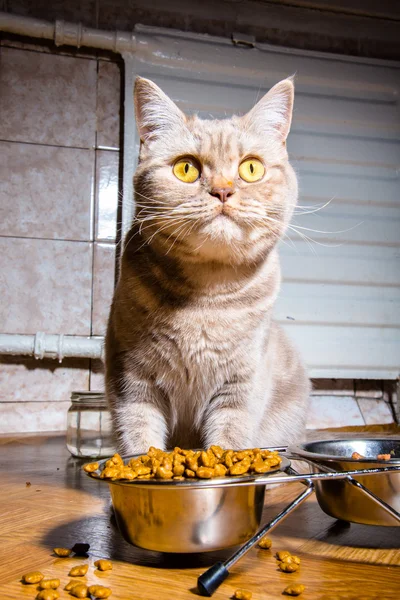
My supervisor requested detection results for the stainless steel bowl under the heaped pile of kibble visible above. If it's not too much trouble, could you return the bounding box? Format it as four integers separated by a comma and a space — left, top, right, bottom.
89, 457, 290, 552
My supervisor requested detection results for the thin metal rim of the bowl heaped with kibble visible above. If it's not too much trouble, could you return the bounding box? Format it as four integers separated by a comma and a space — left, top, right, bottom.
86, 448, 291, 490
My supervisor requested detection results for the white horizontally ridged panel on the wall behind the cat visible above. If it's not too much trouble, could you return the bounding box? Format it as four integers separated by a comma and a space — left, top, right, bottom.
124, 27, 400, 379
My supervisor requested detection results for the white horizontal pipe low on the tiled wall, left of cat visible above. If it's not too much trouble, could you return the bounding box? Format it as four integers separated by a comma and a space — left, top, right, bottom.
0, 331, 104, 362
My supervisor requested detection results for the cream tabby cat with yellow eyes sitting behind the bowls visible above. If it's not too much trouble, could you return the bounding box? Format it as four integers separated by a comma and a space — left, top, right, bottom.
106, 77, 309, 454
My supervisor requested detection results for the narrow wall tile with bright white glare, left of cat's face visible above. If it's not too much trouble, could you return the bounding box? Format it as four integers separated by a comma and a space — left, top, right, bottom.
96, 150, 119, 241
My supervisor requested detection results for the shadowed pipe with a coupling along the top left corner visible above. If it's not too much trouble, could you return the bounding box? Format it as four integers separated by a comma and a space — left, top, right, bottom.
0, 12, 136, 54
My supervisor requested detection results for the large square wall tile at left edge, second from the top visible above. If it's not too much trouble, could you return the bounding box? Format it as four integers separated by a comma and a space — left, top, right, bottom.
0, 142, 94, 240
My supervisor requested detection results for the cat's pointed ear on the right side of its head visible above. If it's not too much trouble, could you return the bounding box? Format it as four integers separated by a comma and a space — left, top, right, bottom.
243, 78, 294, 142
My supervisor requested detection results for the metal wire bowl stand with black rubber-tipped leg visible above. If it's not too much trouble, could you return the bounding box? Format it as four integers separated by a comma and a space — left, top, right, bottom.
197, 447, 400, 596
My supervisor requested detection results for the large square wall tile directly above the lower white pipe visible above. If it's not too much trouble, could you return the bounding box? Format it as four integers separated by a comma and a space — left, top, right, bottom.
0, 237, 92, 335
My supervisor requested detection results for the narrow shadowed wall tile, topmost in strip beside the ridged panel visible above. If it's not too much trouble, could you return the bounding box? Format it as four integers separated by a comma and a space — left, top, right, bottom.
97, 60, 122, 148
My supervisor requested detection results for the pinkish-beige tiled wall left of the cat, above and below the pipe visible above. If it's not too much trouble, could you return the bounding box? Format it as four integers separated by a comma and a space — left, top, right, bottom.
0, 39, 121, 433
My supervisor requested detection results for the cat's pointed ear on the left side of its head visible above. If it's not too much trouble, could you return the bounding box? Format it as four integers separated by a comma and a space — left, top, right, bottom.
133, 77, 186, 142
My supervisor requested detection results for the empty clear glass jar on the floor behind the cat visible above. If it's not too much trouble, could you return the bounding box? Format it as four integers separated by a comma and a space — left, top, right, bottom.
67, 392, 115, 458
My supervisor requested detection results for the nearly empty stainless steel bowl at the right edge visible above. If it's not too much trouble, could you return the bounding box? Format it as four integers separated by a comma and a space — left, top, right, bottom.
290, 438, 400, 526
